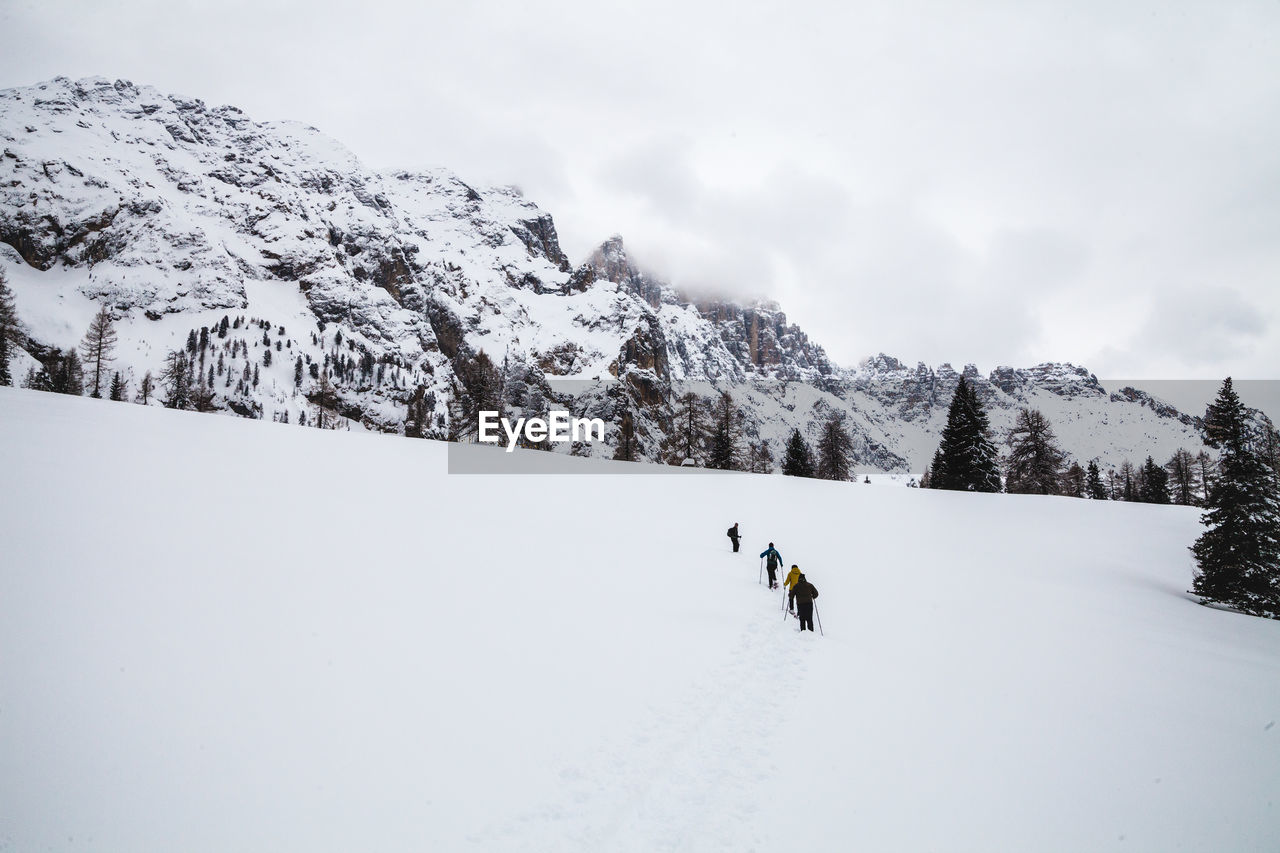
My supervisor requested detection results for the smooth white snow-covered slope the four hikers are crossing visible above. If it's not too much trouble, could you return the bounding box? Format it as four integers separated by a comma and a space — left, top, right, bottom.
0, 388, 1280, 853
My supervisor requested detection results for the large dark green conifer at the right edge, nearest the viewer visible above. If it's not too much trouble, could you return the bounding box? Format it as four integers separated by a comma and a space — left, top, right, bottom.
1192, 378, 1280, 617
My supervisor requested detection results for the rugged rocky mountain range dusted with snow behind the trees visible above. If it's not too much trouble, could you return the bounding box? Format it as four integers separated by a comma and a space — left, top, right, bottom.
0, 78, 1244, 473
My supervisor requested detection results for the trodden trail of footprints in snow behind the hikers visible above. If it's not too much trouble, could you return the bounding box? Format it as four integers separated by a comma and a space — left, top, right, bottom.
468, 581, 819, 853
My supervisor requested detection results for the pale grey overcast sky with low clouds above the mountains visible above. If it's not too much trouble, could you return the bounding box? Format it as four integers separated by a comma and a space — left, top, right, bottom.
0, 0, 1280, 378
